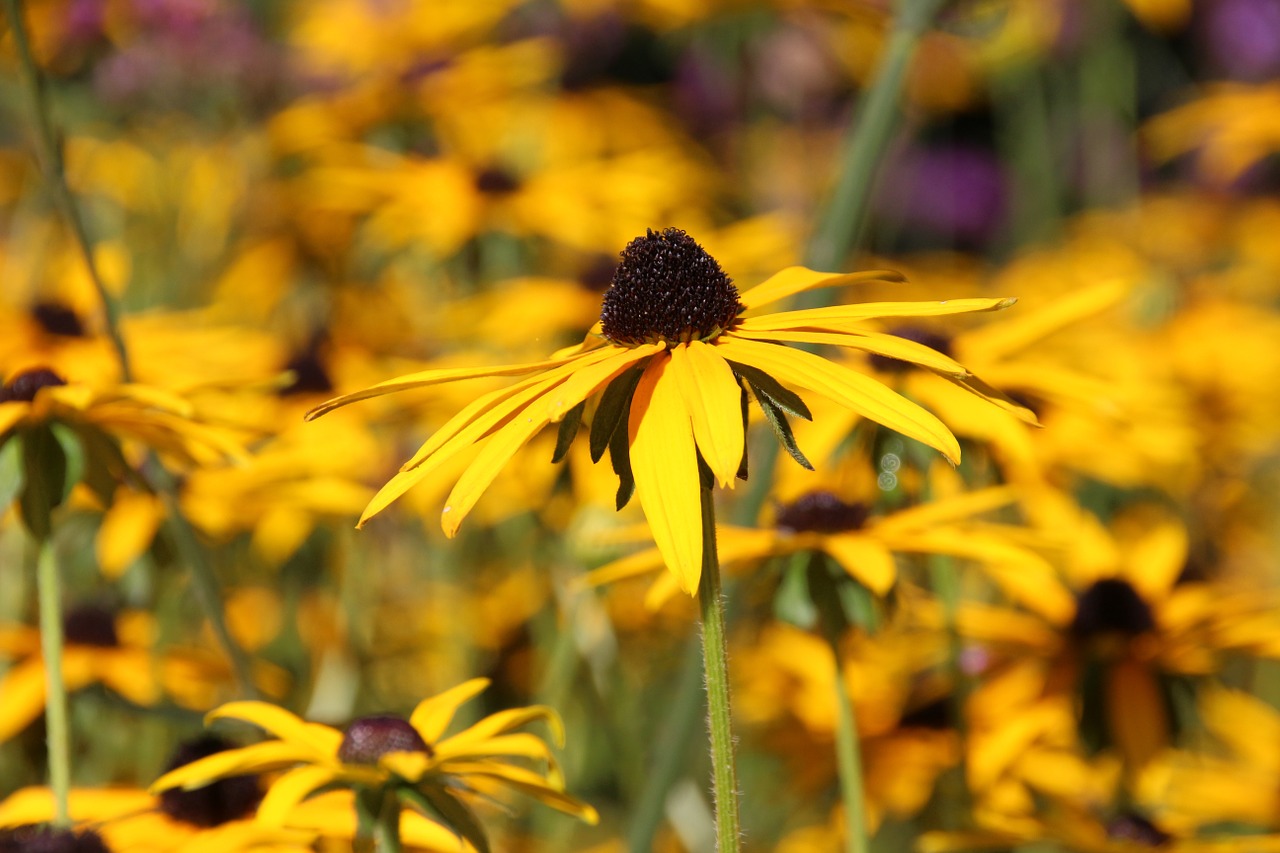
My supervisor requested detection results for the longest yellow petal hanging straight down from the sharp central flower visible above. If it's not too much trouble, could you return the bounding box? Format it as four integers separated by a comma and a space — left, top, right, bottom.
627, 356, 703, 596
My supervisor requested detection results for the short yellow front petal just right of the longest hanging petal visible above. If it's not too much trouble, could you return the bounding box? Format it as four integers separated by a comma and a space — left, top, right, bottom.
669, 341, 745, 488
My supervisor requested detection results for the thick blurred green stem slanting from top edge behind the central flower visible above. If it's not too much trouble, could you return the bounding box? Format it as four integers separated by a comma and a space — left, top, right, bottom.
797, 0, 946, 272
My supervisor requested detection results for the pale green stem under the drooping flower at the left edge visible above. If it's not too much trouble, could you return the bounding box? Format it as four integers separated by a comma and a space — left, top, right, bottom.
36, 539, 72, 829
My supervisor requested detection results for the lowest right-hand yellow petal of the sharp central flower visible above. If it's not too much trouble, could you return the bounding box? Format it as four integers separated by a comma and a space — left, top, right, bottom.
717, 334, 960, 464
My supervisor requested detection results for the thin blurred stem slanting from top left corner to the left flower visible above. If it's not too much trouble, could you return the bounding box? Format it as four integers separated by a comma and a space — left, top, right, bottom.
4, 0, 132, 382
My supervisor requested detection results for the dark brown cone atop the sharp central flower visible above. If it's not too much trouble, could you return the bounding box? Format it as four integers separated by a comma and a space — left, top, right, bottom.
600, 228, 742, 346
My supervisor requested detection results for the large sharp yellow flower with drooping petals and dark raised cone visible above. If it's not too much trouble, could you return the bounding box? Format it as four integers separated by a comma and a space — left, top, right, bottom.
308, 228, 1014, 594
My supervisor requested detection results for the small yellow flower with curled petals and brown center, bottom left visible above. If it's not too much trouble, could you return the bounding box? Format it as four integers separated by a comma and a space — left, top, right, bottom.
151, 679, 596, 848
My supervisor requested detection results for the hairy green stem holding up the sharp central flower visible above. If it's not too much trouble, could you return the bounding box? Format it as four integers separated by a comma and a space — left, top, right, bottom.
698, 489, 742, 853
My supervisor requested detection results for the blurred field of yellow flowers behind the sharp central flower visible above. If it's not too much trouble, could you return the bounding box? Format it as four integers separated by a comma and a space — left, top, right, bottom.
0, 0, 1280, 853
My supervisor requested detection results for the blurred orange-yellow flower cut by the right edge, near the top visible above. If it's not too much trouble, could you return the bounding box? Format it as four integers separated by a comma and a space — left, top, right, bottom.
1142, 83, 1280, 184
